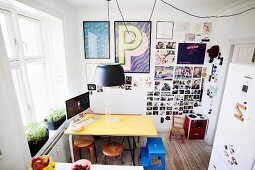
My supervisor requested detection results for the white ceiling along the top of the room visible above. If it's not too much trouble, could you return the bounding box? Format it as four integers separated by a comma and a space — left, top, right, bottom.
65, 0, 248, 11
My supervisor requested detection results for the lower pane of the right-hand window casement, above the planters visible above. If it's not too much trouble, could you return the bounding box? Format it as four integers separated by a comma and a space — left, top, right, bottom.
27, 62, 49, 121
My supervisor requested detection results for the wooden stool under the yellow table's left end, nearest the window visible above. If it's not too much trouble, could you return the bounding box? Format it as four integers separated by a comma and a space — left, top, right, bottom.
73, 136, 97, 163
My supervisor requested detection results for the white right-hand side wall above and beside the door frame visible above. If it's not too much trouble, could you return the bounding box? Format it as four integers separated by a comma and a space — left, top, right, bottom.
203, 1, 255, 144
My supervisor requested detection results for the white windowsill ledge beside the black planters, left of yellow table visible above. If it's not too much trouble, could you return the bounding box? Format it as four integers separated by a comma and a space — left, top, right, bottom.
34, 121, 67, 157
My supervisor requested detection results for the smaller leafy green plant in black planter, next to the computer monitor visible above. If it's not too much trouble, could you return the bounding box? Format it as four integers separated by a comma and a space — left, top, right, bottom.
45, 109, 66, 130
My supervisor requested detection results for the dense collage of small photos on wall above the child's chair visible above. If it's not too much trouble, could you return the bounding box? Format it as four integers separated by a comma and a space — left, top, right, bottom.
146, 66, 206, 123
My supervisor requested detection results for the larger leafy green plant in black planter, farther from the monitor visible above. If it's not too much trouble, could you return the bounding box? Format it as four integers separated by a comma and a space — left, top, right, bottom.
25, 122, 49, 156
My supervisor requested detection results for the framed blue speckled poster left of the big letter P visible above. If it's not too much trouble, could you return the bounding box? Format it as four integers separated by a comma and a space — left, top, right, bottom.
83, 21, 110, 59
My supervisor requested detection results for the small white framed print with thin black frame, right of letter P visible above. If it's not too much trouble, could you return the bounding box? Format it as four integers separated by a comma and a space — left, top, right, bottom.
156, 21, 174, 39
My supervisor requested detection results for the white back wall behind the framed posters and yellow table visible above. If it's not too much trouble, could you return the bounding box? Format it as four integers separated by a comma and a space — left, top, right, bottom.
78, 8, 213, 132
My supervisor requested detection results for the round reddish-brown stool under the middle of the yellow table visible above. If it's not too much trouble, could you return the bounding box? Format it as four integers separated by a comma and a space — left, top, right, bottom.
103, 142, 124, 164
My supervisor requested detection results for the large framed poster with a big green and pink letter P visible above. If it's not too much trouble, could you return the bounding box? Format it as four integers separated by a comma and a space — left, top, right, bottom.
114, 21, 151, 73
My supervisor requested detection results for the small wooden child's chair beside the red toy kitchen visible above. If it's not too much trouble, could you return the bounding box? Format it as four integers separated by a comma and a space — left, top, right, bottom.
169, 115, 185, 144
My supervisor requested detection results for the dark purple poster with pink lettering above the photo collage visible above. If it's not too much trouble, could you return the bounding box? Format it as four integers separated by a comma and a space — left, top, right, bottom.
177, 43, 206, 64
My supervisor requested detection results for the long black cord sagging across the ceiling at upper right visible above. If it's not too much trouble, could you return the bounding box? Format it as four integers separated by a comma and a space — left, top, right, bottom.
161, 0, 255, 18
